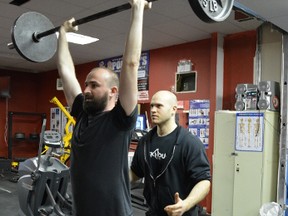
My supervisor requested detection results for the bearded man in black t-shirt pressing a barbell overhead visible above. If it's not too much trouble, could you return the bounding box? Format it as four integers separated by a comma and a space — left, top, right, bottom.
58, 0, 151, 216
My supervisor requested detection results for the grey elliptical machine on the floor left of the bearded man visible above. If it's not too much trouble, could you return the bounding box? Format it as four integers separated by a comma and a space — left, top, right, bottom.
17, 119, 72, 216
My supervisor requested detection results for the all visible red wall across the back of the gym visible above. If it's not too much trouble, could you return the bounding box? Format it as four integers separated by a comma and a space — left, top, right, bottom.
0, 31, 256, 212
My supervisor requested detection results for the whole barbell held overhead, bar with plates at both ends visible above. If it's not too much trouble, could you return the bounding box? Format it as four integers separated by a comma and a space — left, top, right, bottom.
7, 0, 234, 62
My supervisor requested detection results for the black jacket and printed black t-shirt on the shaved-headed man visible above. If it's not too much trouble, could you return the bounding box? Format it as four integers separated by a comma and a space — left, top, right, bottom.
131, 127, 211, 216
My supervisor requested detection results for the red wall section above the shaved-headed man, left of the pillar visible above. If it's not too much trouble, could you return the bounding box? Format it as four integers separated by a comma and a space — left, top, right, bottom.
149, 39, 210, 100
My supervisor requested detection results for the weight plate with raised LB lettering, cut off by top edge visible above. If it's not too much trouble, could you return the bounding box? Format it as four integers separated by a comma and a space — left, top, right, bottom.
189, 0, 234, 23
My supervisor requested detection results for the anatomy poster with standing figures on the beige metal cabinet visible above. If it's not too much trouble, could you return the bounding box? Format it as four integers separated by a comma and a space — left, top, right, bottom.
235, 112, 264, 152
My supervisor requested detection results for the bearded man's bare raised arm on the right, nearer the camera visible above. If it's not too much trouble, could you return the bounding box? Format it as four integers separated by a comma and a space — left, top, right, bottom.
119, 0, 152, 115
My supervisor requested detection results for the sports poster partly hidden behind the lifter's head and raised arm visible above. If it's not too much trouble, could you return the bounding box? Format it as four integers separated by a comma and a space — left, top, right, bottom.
98, 51, 150, 100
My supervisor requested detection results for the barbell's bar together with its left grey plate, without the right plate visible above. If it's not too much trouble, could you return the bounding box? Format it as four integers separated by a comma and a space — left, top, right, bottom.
7, 0, 157, 62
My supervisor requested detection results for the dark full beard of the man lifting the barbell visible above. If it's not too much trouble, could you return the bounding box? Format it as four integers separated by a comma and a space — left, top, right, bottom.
83, 92, 108, 115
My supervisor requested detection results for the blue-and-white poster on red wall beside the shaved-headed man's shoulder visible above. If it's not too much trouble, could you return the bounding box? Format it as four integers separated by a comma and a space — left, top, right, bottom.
188, 100, 210, 148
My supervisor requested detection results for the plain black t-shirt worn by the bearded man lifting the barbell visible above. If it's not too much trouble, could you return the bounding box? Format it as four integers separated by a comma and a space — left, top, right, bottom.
71, 95, 137, 216
